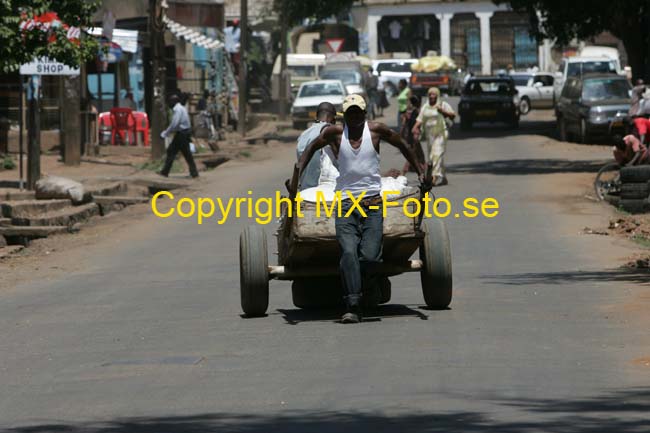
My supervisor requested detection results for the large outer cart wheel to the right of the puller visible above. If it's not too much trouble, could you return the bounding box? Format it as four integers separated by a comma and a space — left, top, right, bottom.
420, 218, 452, 310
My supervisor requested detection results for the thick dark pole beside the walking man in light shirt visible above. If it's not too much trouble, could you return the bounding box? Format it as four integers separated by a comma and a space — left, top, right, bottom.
149, 0, 167, 160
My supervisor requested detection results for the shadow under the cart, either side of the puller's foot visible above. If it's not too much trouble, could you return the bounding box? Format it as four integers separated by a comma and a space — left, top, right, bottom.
277, 304, 429, 325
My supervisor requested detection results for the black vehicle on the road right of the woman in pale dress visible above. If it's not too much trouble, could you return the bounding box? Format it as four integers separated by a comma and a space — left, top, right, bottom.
458, 76, 519, 130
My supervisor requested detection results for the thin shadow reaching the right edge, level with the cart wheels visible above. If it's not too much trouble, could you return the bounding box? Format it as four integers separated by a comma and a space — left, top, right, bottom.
483, 268, 650, 286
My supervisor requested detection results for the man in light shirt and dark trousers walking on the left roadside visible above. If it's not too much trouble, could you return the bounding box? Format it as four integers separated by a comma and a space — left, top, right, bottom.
160, 94, 199, 178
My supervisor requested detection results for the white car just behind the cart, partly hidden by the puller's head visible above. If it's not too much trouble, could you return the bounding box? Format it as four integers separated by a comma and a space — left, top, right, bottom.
291, 80, 348, 129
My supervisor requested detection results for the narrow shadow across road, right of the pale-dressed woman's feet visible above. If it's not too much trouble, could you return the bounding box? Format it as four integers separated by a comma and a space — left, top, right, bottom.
447, 159, 606, 175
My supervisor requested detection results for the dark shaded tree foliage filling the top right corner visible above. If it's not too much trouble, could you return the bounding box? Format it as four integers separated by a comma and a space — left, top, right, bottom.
494, 0, 650, 78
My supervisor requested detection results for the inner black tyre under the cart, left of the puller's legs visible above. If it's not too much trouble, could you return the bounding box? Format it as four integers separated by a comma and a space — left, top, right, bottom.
291, 278, 343, 310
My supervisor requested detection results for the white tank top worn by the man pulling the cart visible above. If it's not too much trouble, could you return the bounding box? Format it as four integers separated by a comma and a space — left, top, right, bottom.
336, 122, 381, 199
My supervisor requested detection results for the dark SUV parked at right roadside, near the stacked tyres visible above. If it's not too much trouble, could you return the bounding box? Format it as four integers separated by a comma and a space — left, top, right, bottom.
555, 74, 631, 143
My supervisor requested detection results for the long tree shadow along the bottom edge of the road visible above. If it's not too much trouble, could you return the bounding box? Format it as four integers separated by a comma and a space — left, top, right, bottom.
8, 388, 650, 433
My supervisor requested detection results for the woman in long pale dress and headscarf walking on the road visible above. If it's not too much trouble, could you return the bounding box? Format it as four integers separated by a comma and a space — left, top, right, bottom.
413, 87, 456, 186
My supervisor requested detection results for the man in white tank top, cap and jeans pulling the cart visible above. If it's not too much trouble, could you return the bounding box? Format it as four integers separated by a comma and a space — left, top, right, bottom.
292, 95, 424, 323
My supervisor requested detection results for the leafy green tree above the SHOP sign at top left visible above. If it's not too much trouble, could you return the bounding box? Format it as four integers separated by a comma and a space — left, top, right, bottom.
0, 0, 99, 73
